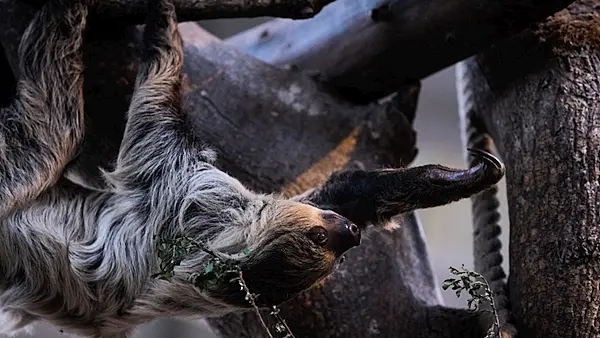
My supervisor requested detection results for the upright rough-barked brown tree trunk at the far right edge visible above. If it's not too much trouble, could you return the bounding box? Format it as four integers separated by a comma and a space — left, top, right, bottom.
457, 0, 600, 338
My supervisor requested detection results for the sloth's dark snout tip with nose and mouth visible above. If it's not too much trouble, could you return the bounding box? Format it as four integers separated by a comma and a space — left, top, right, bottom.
323, 210, 360, 256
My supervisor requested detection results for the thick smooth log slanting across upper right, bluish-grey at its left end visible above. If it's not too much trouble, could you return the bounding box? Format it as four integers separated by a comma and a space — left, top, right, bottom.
227, 0, 573, 102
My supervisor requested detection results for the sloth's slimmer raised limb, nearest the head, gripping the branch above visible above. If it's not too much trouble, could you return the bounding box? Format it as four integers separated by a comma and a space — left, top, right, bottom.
108, 0, 212, 190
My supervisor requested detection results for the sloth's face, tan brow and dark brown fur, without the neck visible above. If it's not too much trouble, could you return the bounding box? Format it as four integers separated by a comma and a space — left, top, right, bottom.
219, 201, 361, 305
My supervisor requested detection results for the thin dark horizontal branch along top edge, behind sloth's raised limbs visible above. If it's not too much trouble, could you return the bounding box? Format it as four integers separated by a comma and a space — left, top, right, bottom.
16, 0, 334, 25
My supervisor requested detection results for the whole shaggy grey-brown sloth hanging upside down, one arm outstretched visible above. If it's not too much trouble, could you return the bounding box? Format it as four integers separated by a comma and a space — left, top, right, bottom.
0, 0, 504, 338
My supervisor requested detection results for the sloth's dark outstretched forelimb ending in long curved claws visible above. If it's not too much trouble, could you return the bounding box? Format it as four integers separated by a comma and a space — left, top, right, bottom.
299, 150, 504, 227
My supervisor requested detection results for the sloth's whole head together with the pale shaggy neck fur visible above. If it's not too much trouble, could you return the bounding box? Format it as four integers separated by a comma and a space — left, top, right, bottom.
163, 169, 361, 307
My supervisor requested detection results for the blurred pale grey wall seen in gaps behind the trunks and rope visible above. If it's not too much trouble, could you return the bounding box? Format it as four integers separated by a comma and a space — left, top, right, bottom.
7, 19, 508, 338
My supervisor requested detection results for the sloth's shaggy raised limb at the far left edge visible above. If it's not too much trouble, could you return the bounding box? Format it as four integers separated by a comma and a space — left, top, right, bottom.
0, 0, 87, 218
